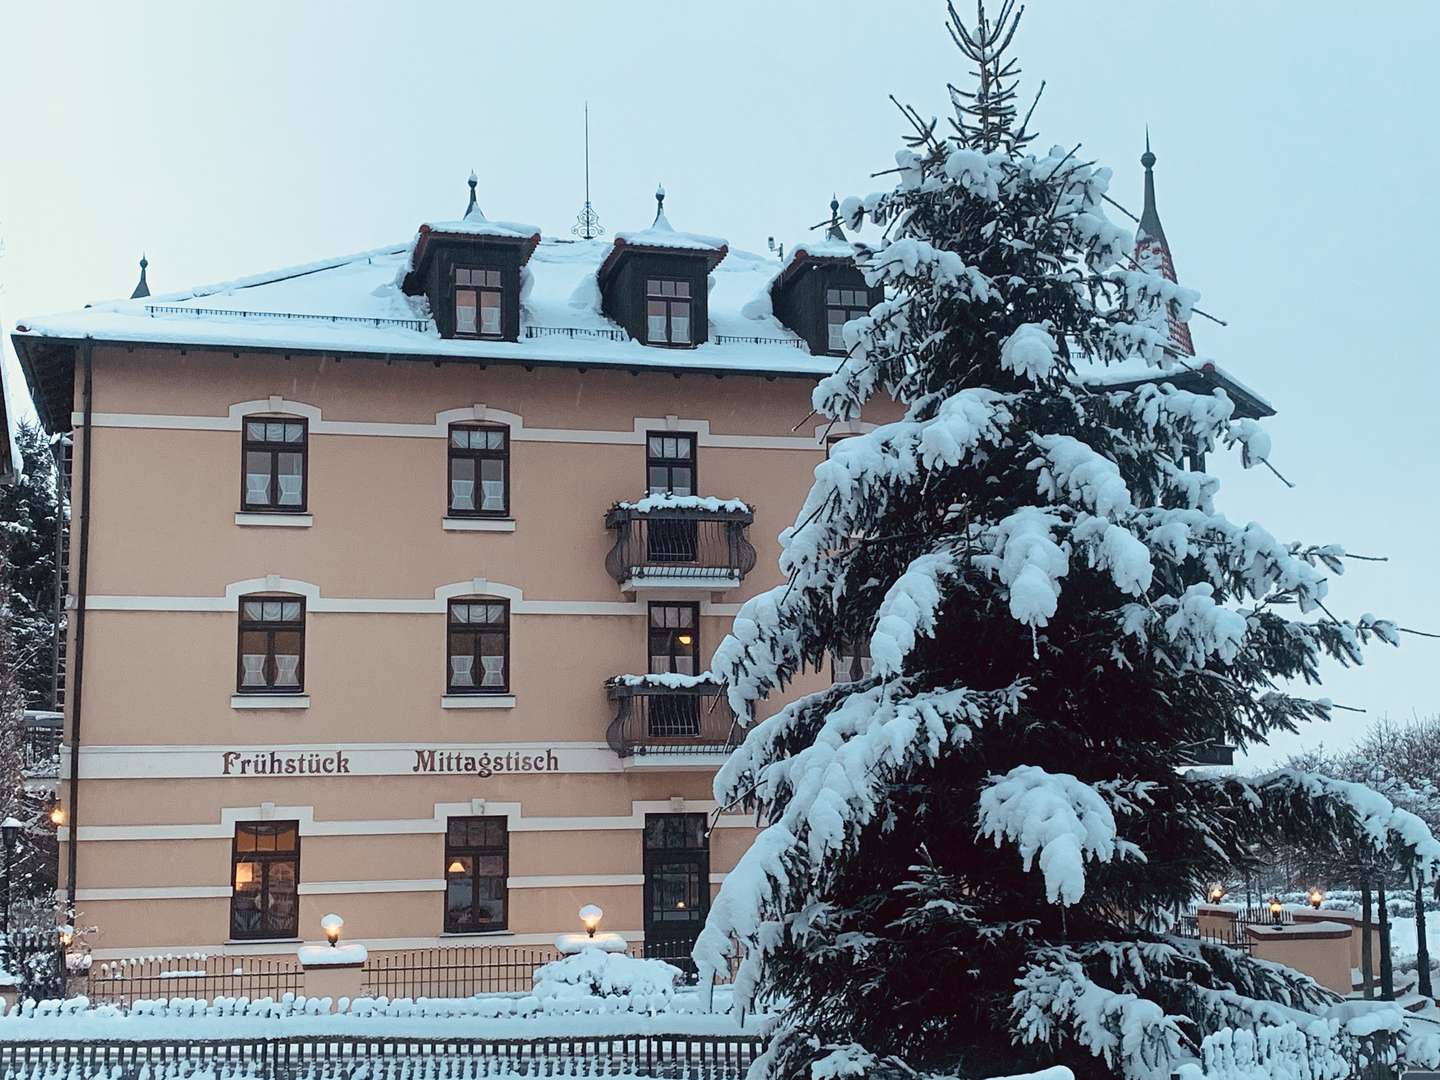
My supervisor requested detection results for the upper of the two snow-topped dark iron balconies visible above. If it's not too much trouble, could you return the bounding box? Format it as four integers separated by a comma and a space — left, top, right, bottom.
605, 495, 755, 592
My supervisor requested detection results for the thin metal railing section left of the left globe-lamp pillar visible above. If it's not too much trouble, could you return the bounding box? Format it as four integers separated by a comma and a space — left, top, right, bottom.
85, 956, 304, 1005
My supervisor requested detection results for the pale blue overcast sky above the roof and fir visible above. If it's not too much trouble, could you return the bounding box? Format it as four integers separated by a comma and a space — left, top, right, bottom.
0, 0, 1440, 765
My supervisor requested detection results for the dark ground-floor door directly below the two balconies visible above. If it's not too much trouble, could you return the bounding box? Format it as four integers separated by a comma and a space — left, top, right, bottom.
645, 814, 710, 971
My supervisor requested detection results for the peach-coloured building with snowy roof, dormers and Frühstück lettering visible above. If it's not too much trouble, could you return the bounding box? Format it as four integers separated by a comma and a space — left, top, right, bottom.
13, 177, 880, 958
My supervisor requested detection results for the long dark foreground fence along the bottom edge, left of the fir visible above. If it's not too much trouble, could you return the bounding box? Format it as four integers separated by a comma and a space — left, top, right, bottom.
0, 1034, 763, 1080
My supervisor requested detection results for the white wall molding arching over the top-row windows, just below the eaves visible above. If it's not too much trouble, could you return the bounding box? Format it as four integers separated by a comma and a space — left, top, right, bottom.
71, 406, 840, 452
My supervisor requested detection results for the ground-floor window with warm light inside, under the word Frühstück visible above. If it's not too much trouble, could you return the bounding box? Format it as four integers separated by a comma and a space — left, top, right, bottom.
230, 821, 300, 939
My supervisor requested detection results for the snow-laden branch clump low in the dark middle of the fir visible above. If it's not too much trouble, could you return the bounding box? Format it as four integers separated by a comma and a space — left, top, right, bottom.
979, 765, 1116, 906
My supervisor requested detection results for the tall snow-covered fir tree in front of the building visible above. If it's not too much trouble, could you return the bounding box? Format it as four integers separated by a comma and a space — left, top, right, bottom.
696, 4, 1440, 1080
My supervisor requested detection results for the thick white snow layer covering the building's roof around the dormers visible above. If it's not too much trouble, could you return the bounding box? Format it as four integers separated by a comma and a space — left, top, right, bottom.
16, 236, 835, 377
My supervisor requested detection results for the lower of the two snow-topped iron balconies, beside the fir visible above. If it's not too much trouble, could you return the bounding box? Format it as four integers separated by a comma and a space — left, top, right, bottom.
605, 674, 740, 768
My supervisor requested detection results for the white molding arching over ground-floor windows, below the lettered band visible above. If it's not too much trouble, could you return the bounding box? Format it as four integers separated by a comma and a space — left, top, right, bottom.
59, 799, 755, 846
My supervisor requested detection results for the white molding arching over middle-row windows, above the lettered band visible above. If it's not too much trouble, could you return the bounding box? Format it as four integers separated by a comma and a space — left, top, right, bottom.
85, 573, 740, 618
